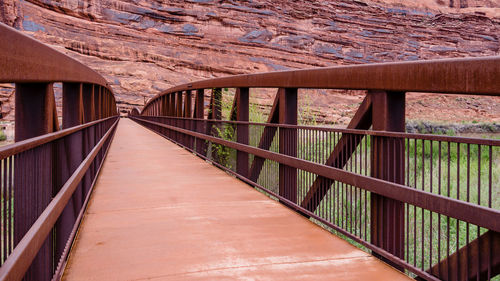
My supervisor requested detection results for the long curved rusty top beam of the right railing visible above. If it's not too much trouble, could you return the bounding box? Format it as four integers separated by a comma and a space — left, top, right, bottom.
142, 56, 500, 111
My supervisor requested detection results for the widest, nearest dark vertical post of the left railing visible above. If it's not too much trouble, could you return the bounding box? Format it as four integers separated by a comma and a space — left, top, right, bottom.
13, 83, 58, 280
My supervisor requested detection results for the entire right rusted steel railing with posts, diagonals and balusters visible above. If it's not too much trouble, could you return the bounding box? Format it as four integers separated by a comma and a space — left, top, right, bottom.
130, 57, 500, 280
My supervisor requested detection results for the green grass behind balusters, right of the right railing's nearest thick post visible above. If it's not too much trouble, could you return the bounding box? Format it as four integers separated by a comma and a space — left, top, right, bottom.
406, 137, 500, 268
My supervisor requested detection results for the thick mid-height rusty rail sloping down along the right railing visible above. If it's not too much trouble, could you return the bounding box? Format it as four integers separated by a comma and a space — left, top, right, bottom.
133, 116, 500, 232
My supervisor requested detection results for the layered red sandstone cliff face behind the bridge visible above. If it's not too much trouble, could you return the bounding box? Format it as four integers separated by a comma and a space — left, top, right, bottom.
0, 0, 500, 122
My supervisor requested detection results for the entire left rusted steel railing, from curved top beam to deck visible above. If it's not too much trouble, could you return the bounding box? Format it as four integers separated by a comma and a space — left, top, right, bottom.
0, 24, 118, 280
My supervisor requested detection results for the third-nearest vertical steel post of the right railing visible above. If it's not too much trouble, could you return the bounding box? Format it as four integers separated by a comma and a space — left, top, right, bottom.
235, 88, 249, 178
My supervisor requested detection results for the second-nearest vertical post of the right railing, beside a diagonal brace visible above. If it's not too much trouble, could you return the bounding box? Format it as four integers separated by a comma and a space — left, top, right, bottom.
278, 88, 297, 203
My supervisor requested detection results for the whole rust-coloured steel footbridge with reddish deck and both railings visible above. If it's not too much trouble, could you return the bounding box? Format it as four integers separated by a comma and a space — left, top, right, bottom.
0, 24, 500, 281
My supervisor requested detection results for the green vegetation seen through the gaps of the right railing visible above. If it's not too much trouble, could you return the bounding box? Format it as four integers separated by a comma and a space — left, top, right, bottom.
204, 91, 500, 276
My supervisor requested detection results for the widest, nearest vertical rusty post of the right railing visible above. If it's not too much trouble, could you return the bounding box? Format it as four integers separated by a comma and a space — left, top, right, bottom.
368, 91, 405, 270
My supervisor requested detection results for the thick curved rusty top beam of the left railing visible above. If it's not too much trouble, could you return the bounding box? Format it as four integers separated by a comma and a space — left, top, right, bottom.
0, 23, 111, 87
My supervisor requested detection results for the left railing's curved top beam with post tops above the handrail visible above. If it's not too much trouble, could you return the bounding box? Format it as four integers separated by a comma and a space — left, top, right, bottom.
0, 23, 118, 141
